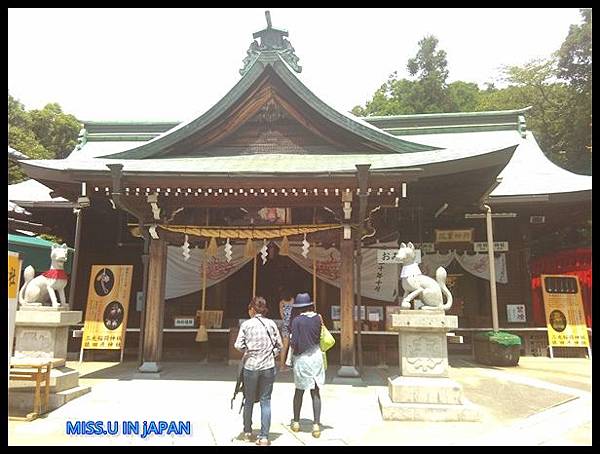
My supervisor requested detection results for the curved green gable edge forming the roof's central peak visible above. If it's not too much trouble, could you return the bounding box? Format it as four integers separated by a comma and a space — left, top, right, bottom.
98, 55, 440, 159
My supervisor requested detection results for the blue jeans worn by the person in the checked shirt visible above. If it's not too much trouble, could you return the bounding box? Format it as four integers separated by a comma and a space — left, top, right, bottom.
244, 367, 275, 438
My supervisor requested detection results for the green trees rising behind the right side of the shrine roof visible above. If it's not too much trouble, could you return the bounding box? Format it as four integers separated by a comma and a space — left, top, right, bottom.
352, 20, 592, 175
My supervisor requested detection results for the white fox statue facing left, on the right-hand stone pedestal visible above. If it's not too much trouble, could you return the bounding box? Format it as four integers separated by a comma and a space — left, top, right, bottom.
396, 242, 452, 311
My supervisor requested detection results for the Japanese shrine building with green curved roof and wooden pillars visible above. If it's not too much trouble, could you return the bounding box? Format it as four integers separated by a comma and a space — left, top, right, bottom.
19, 14, 591, 375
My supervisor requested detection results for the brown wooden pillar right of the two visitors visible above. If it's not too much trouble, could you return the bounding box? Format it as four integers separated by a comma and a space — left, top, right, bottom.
337, 233, 359, 377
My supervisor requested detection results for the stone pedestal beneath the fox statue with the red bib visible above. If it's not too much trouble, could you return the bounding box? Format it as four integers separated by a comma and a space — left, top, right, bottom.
9, 306, 90, 411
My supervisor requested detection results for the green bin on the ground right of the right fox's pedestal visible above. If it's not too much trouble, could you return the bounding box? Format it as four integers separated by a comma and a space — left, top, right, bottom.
473, 331, 521, 366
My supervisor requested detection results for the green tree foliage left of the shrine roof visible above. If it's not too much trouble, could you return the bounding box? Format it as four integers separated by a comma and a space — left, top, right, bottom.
8, 94, 81, 184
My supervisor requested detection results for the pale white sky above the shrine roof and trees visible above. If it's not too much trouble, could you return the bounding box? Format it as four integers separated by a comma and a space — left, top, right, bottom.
8, 8, 581, 121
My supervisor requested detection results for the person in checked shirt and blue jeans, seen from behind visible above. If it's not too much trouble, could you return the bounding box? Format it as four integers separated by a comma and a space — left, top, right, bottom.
234, 296, 281, 446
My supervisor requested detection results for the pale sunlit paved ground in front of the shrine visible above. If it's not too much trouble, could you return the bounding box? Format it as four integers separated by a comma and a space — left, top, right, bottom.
9, 357, 591, 446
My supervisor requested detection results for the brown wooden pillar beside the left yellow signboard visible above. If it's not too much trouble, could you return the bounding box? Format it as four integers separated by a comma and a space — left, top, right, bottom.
139, 238, 167, 372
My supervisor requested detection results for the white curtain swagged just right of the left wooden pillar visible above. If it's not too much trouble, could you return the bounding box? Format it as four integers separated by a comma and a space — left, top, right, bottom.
165, 244, 252, 299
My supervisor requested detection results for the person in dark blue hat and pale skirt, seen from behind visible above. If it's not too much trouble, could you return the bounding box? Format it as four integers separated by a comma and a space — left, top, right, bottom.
290, 293, 325, 438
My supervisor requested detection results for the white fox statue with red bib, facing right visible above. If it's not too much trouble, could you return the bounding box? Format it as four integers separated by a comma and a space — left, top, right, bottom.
19, 244, 69, 307
